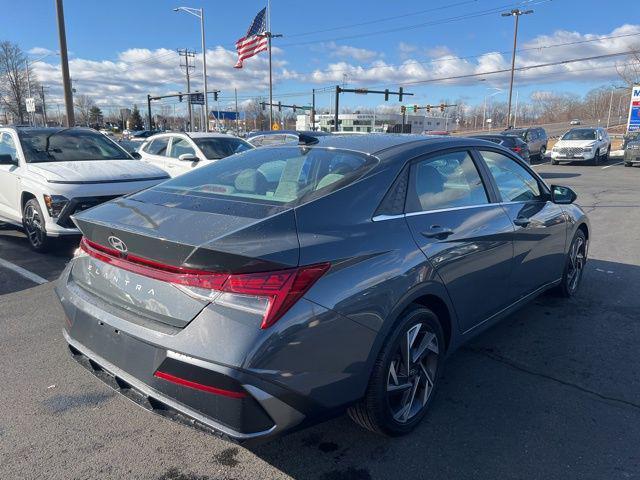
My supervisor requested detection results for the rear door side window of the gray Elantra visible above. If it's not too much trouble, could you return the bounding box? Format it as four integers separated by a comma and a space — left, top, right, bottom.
406, 151, 489, 212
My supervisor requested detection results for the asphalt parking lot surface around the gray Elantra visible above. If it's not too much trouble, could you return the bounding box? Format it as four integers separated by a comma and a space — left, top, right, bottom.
0, 158, 640, 480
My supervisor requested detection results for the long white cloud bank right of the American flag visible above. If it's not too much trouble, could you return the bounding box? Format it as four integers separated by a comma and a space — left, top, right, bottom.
303, 25, 640, 85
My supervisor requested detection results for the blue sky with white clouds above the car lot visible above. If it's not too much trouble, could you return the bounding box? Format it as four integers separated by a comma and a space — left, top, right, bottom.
0, 0, 640, 115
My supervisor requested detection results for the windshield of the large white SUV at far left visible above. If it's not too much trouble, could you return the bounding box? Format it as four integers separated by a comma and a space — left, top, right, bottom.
18, 129, 131, 163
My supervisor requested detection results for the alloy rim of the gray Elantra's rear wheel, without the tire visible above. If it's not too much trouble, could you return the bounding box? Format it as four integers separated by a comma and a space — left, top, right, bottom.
387, 323, 440, 424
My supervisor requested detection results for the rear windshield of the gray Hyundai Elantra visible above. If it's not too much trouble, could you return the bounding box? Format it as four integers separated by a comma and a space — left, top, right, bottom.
154, 146, 377, 204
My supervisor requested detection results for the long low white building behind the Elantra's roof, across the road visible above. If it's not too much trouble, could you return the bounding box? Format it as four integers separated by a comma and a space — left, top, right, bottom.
296, 113, 455, 133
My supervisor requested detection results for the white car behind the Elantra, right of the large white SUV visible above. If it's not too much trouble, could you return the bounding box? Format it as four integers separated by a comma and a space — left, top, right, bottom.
139, 132, 254, 177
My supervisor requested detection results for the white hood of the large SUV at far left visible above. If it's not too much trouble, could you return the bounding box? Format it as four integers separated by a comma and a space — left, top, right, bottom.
28, 160, 168, 183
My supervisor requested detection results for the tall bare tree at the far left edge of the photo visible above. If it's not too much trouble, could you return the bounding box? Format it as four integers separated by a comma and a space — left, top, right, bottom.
0, 41, 28, 123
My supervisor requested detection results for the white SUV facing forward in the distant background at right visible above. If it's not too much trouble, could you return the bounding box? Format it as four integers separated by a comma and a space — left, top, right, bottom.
551, 127, 611, 165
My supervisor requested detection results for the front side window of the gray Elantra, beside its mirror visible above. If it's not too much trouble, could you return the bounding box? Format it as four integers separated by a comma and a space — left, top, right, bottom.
480, 150, 542, 202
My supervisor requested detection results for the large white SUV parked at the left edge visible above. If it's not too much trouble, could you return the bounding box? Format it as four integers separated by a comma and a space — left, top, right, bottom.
0, 127, 169, 252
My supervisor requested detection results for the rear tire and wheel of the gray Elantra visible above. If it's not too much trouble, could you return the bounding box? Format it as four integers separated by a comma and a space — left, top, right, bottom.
349, 305, 445, 436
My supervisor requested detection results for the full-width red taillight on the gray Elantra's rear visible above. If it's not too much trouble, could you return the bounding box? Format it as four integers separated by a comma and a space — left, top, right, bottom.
80, 237, 331, 329
